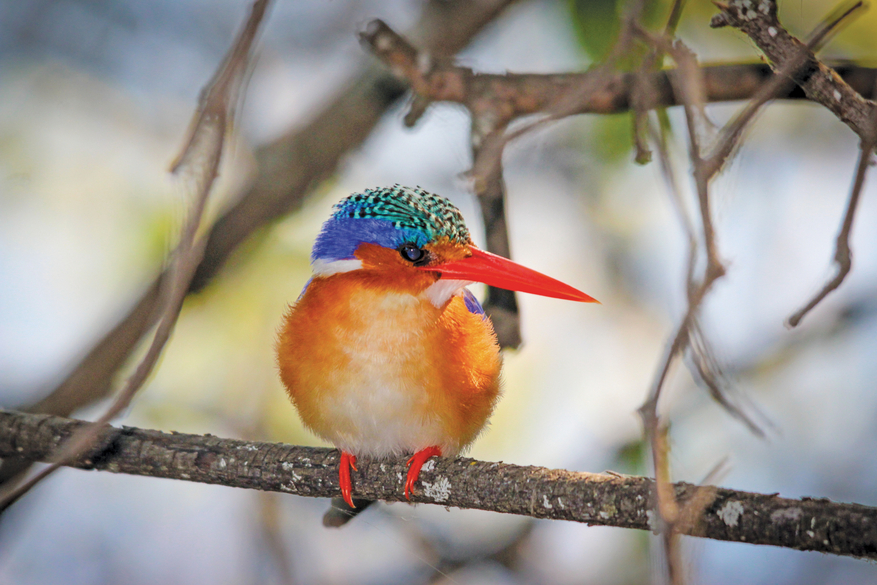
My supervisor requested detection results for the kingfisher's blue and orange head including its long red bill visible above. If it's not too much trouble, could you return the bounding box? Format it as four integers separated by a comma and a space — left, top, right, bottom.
311, 185, 597, 306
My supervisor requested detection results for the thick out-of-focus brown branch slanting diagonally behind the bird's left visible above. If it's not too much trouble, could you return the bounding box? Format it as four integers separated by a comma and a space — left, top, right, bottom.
0, 0, 514, 488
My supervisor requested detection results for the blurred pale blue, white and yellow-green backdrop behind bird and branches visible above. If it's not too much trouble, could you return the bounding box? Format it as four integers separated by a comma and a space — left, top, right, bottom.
0, 0, 877, 585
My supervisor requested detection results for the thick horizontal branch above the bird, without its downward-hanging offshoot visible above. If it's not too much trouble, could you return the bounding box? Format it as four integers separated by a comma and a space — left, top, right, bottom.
362, 20, 877, 125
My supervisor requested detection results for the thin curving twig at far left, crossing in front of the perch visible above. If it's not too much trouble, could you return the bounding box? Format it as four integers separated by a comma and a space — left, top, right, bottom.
0, 0, 268, 512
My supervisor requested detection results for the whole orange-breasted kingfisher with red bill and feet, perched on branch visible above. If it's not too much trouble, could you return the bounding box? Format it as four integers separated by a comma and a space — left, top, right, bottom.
276, 184, 598, 526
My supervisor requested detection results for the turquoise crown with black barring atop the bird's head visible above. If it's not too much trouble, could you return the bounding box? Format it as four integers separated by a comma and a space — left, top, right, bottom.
332, 184, 471, 244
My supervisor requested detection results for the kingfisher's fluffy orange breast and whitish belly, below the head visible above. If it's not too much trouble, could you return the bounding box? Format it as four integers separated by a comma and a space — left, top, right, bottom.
277, 270, 501, 457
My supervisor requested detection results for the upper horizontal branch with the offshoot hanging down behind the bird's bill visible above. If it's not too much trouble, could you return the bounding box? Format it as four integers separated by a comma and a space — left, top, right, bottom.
360, 17, 877, 347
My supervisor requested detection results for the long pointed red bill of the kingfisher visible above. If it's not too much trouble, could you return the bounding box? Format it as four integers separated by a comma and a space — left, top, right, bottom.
421, 246, 600, 303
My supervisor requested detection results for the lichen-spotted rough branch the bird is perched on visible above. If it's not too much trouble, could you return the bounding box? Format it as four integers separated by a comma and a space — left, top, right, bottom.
0, 411, 877, 559
